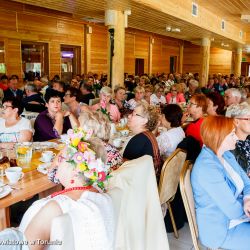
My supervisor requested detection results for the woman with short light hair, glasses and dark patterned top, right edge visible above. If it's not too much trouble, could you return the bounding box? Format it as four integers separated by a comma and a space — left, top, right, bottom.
226, 102, 250, 177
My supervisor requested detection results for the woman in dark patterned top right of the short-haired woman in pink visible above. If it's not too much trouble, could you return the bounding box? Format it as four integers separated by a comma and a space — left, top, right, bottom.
111, 86, 130, 116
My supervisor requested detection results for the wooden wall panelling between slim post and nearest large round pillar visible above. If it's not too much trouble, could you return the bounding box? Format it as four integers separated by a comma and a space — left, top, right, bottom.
91, 25, 109, 73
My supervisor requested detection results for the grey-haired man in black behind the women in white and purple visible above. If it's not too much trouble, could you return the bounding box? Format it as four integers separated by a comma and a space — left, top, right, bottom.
22, 82, 46, 113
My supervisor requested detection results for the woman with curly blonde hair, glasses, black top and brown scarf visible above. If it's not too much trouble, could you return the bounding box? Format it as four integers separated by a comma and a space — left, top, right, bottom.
123, 102, 162, 180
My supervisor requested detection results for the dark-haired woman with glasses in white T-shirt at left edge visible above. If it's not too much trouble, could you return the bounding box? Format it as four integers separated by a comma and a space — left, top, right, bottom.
0, 97, 33, 148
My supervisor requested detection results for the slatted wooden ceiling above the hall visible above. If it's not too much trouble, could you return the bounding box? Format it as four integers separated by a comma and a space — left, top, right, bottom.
12, 0, 250, 50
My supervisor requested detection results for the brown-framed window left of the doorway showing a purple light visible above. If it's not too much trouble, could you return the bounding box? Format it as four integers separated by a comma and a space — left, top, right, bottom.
21, 42, 49, 81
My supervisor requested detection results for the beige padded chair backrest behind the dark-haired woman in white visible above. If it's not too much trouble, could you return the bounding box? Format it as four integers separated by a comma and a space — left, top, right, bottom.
158, 149, 186, 204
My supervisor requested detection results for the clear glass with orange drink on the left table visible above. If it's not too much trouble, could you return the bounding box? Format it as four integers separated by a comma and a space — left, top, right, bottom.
15, 142, 32, 167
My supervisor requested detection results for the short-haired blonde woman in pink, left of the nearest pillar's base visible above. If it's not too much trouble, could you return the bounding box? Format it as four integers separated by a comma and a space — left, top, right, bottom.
91, 86, 121, 122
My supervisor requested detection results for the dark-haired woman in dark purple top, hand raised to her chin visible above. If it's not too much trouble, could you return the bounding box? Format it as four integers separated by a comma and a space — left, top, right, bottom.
34, 92, 79, 141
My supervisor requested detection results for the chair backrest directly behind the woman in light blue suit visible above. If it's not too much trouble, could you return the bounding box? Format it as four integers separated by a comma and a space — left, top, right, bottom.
180, 161, 199, 250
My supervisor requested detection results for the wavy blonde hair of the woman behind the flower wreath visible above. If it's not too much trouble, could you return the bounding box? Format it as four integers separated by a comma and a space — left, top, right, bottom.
78, 111, 111, 141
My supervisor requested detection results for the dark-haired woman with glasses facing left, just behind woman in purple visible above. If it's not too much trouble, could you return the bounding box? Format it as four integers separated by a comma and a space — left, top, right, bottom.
63, 87, 89, 118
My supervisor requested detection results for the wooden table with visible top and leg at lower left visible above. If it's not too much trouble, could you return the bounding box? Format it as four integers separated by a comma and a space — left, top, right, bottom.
0, 146, 62, 230
